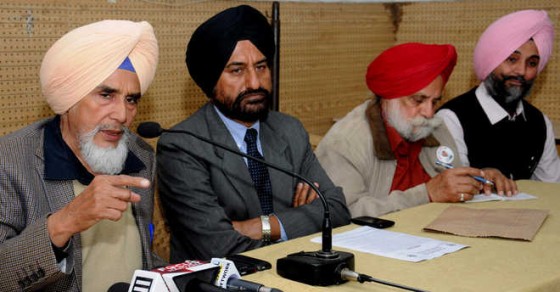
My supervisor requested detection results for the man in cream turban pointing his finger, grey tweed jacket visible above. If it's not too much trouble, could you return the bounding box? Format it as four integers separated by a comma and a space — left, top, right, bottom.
0, 20, 162, 291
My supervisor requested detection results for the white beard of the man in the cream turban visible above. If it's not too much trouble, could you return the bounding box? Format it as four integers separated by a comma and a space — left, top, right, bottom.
79, 125, 130, 175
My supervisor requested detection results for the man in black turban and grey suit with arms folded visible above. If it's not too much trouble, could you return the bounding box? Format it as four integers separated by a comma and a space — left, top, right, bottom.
157, 5, 350, 262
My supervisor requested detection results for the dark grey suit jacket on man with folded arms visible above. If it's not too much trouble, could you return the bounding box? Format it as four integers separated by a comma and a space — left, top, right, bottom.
157, 103, 350, 262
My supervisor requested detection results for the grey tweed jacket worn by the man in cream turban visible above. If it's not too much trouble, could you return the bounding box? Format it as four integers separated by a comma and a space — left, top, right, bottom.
0, 120, 162, 291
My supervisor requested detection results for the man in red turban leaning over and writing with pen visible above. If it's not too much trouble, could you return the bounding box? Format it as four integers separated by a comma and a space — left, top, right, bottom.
315, 43, 507, 217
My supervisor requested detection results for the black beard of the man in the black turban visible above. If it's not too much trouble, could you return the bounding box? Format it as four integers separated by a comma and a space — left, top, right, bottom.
212, 87, 272, 123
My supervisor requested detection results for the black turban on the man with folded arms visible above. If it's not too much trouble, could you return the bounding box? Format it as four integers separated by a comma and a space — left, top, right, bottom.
186, 5, 274, 98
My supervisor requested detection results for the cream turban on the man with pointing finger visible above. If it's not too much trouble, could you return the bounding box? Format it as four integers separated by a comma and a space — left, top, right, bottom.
40, 20, 158, 114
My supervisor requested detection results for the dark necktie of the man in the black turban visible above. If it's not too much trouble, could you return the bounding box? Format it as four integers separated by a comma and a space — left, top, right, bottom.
244, 129, 274, 215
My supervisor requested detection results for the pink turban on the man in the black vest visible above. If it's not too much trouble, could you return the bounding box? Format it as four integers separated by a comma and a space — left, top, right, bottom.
474, 10, 554, 80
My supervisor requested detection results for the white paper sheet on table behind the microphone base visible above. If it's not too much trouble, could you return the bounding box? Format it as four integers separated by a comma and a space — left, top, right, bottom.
311, 226, 467, 262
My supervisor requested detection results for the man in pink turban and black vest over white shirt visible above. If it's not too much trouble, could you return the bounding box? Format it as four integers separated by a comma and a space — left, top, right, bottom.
437, 10, 560, 182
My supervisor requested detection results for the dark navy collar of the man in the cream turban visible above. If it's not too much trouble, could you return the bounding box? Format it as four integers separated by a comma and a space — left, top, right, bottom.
43, 115, 146, 185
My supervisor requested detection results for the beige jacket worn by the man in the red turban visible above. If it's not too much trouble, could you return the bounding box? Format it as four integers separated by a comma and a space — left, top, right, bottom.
315, 100, 460, 217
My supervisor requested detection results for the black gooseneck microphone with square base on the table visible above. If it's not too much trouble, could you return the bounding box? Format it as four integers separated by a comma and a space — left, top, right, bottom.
137, 122, 354, 286
